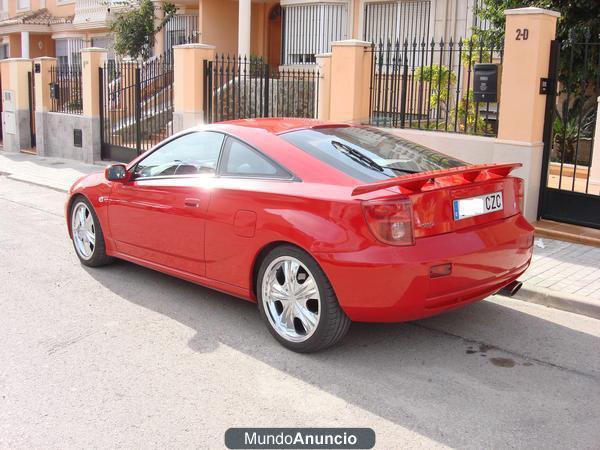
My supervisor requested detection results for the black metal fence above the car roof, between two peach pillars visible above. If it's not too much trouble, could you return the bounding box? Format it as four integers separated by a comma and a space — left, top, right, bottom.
204, 55, 319, 123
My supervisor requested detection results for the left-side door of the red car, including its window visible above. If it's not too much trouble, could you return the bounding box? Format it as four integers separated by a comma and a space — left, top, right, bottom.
108, 131, 224, 276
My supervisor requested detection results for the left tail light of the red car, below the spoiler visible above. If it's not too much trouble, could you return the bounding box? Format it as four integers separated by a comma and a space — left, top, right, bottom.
362, 198, 415, 245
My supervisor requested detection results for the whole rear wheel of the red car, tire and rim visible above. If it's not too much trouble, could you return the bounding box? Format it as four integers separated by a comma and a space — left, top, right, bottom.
257, 245, 350, 353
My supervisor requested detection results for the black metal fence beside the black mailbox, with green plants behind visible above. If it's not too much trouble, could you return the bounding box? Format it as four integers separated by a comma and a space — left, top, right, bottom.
369, 39, 502, 136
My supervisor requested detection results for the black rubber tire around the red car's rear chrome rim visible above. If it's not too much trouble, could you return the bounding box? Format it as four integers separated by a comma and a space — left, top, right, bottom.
256, 245, 351, 353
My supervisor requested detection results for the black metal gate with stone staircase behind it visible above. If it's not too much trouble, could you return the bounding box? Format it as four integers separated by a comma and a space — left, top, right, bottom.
100, 56, 173, 162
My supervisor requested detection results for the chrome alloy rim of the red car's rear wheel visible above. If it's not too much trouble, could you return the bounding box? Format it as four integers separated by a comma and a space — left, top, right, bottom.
261, 256, 321, 342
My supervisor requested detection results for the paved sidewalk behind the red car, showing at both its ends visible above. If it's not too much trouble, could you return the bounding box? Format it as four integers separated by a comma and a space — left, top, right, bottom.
0, 152, 600, 319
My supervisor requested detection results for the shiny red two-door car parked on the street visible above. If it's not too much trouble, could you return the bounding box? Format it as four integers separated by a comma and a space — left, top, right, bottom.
66, 119, 533, 352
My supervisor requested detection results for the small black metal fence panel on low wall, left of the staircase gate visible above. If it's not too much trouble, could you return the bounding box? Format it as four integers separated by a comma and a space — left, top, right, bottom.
50, 64, 83, 114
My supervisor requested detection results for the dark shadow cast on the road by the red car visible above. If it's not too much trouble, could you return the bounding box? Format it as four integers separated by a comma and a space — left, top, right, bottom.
86, 261, 600, 448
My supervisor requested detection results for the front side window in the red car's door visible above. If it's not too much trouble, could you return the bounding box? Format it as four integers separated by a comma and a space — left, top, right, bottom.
135, 131, 225, 178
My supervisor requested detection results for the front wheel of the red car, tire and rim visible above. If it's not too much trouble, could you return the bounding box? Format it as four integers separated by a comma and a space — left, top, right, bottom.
71, 197, 112, 267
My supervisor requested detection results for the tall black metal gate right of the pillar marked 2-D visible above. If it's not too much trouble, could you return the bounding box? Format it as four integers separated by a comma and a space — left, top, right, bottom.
538, 34, 600, 229
